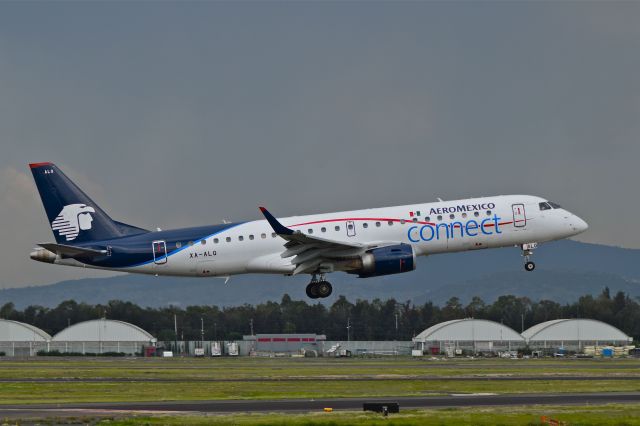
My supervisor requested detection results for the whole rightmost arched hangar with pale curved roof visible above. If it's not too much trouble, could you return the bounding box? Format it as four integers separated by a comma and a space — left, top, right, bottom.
522, 319, 633, 352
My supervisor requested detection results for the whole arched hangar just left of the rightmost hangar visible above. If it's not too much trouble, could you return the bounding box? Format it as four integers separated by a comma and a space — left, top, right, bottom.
413, 318, 525, 356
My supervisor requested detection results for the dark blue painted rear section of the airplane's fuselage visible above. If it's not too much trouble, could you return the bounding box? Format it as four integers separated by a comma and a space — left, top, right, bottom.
70, 222, 245, 268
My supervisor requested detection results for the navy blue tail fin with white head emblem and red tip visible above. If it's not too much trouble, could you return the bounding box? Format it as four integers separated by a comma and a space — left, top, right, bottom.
29, 163, 149, 244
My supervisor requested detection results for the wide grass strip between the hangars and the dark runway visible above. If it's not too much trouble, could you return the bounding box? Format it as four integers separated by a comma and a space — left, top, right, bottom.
0, 358, 640, 404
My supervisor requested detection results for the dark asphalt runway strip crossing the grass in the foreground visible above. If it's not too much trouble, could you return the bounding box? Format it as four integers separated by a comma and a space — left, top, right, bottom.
0, 392, 640, 418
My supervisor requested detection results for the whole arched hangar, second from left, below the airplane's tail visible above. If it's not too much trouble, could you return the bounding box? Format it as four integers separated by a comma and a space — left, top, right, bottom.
48, 318, 156, 355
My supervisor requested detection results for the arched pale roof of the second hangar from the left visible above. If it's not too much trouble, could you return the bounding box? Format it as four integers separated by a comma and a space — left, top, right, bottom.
52, 319, 154, 342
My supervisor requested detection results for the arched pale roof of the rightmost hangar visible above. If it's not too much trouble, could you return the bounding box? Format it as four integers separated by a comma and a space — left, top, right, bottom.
522, 319, 631, 341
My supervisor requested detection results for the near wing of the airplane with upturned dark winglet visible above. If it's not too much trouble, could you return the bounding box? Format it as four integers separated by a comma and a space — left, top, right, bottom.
260, 207, 370, 275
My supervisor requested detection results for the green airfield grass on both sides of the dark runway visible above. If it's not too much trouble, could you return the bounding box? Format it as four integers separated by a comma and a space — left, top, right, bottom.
0, 357, 640, 426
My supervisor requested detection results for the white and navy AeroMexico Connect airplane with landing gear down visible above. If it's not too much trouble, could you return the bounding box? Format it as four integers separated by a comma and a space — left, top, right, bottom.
29, 162, 588, 299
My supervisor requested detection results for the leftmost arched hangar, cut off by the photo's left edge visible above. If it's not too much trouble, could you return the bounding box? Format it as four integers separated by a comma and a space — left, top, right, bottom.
0, 319, 51, 356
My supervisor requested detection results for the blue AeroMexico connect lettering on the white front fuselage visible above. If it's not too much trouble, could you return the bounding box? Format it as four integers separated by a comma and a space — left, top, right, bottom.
407, 203, 502, 243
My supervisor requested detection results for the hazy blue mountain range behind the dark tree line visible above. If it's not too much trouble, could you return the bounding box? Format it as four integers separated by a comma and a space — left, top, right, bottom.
0, 241, 640, 309
